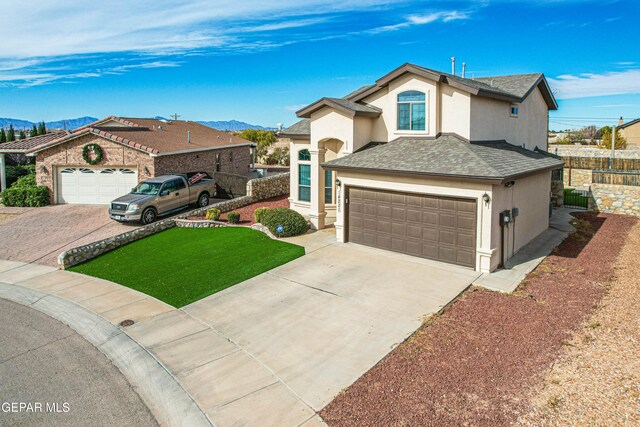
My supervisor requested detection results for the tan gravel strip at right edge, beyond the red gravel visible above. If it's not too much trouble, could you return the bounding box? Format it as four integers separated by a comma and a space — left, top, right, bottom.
519, 219, 640, 426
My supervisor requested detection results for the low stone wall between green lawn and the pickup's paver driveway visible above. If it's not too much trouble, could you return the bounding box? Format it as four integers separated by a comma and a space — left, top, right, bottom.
58, 173, 289, 270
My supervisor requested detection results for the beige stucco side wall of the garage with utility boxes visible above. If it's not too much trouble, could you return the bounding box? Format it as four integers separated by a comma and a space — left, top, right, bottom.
491, 172, 551, 269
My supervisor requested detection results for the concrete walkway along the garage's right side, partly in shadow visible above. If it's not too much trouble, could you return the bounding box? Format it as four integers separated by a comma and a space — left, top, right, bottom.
473, 208, 575, 292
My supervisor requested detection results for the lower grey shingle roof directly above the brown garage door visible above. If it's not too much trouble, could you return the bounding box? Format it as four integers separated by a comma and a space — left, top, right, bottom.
323, 134, 563, 181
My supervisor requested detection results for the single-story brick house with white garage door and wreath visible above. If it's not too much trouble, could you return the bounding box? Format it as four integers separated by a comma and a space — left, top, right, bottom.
0, 116, 253, 204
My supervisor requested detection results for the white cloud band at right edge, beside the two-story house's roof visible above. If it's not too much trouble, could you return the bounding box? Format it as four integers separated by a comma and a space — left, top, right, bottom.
548, 69, 640, 99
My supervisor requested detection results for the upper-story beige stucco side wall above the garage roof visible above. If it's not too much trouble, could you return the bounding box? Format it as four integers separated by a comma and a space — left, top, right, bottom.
470, 88, 548, 150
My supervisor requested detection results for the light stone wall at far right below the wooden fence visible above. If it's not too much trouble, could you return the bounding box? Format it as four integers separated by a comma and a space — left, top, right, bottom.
589, 184, 640, 216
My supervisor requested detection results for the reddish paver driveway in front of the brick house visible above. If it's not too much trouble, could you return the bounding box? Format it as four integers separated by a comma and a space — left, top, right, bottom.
0, 205, 140, 267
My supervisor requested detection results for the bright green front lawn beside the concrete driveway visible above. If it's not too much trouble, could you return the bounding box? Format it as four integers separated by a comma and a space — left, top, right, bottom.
69, 227, 304, 307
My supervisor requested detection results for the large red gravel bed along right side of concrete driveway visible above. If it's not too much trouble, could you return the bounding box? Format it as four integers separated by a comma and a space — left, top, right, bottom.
320, 212, 637, 426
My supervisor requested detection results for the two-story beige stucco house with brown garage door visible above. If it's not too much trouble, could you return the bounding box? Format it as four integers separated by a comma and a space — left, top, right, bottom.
282, 64, 562, 272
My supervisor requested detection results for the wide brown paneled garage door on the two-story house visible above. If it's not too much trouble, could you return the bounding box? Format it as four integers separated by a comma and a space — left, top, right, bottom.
347, 187, 476, 268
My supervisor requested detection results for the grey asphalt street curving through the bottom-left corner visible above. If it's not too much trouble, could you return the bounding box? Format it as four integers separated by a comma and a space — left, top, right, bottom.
0, 299, 157, 426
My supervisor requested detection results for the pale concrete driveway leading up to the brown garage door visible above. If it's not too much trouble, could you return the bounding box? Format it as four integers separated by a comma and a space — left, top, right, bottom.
154, 230, 479, 425
